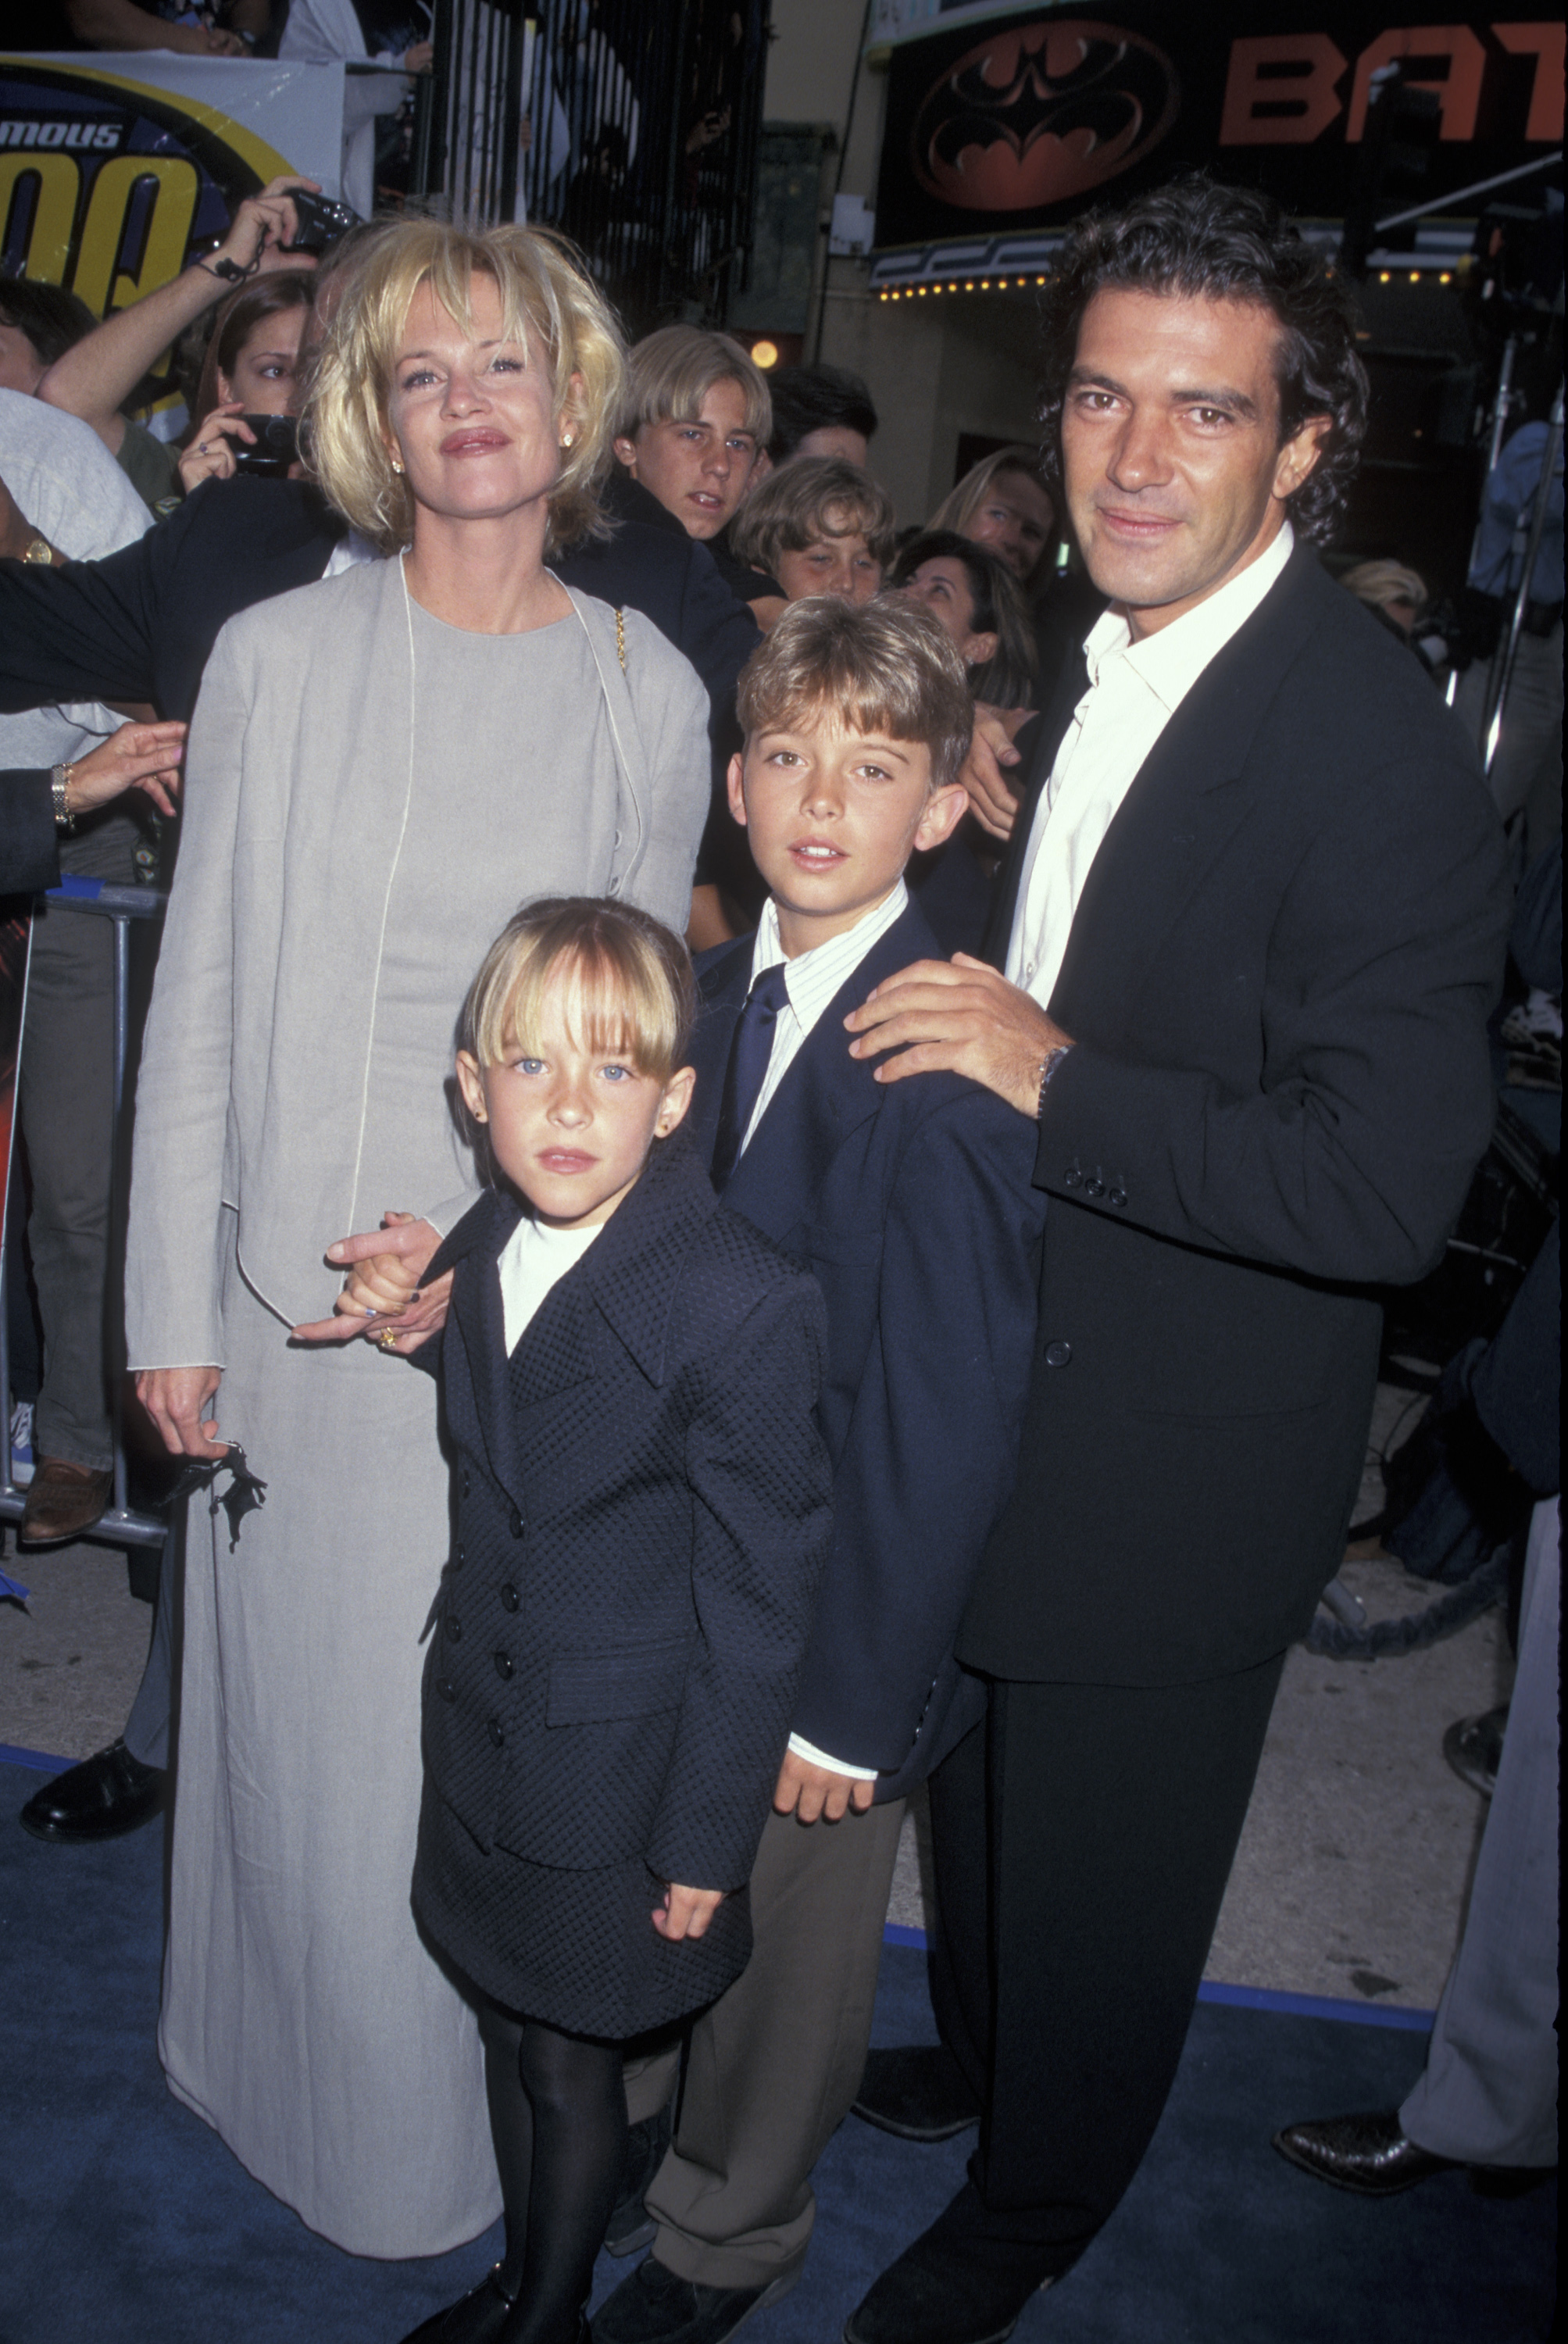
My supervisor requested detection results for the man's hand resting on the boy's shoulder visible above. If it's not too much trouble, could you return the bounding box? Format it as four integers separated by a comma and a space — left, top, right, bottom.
844, 952, 1071, 1120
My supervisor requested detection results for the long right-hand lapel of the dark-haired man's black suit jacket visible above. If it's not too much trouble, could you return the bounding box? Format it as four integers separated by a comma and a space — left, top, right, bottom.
1050, 541, 1327, 1038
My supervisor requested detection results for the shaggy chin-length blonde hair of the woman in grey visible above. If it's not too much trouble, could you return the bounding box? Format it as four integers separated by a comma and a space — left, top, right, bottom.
302, 220, 626, 553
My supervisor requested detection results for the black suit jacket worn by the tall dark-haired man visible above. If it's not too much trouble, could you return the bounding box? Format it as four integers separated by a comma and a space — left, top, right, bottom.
959, 546, 1509, 1685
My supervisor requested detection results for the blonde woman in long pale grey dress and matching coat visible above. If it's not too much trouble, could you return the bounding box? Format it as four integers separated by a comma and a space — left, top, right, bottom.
127, 223, 708, 2255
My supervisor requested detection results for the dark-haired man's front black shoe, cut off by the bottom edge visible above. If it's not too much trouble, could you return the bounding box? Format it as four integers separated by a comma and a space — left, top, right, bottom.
844, 2182, 1059, 2344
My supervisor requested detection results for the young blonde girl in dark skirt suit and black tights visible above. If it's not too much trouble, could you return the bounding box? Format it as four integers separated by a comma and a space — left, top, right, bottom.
408, 898, 830, 2344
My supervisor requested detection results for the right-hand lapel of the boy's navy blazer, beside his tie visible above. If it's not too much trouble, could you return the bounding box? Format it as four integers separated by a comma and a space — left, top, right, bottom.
708, 905, 942, 1240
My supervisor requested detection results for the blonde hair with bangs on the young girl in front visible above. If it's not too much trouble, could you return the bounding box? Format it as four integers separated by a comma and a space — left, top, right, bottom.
457, 895, 696, 1083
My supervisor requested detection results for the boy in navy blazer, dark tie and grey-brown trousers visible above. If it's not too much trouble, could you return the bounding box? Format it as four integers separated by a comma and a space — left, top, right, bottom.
593, 598, 1043, 2344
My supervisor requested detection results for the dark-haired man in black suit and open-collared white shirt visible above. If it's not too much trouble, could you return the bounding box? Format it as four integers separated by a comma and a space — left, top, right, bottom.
846, 180, 1507, 2344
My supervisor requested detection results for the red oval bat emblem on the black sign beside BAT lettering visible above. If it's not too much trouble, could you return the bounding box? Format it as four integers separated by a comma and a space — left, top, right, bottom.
912, 16, 1179, 211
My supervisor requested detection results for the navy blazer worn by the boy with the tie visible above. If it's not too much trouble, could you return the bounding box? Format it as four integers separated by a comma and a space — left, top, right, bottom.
691, 907, 1045, 1798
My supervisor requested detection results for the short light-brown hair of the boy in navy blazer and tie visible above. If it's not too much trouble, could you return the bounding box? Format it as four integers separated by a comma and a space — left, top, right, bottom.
736, 595, 975, 790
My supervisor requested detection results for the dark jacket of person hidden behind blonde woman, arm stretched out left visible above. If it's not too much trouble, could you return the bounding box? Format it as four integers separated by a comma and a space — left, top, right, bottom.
0, 478, 757, 717
